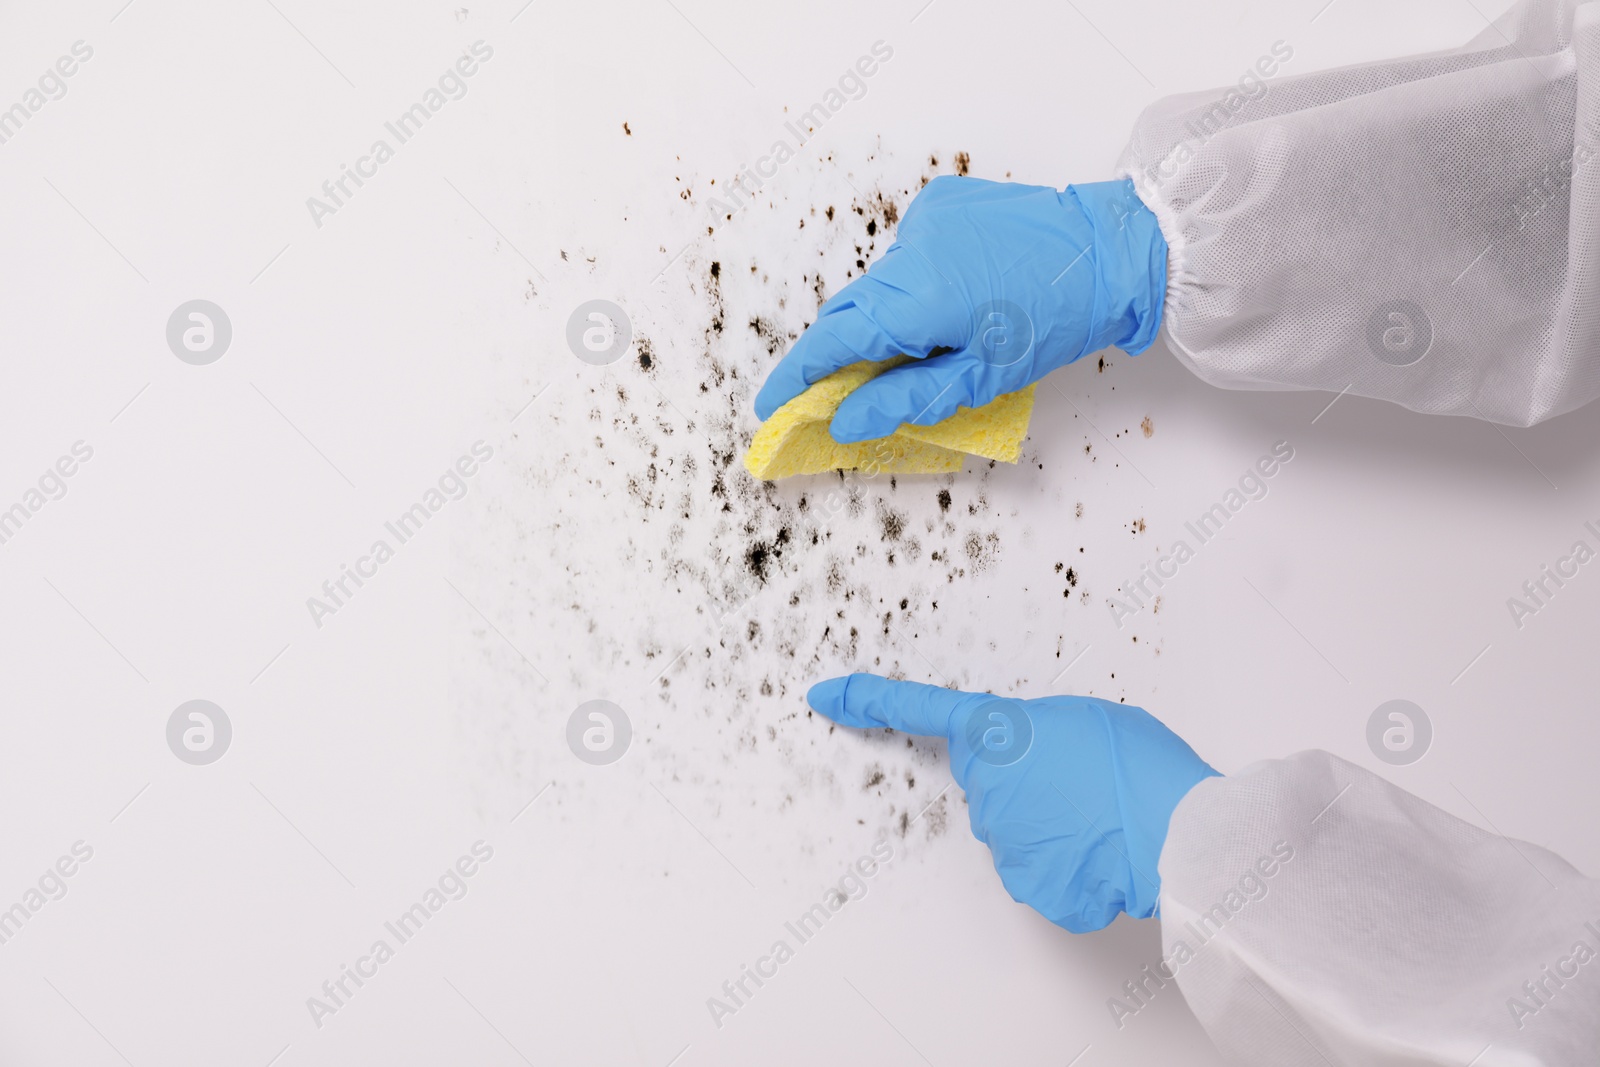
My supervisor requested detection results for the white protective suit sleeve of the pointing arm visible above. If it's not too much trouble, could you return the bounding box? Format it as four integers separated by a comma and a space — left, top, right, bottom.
1158, 752, 1600, 1067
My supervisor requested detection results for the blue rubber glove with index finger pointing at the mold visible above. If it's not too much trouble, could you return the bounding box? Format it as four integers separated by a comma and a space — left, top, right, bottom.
806, 673, 1216, 934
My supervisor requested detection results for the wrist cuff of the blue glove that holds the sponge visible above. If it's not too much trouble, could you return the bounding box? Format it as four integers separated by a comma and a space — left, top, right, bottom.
1067, 178, 1166, 357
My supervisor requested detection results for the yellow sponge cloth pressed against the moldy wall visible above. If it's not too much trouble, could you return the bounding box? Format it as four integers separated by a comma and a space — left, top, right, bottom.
744, 355, 1034, 480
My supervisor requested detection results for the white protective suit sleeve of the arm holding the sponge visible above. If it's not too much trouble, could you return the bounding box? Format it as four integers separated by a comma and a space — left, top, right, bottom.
1118, 0, 1600, 426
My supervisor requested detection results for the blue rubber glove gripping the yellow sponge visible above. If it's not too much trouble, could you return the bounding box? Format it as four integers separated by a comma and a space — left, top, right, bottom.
755, 176, 1166, 442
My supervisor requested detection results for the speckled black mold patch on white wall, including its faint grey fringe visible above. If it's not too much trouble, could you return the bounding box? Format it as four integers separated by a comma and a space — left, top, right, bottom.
462, 143, 1036, 849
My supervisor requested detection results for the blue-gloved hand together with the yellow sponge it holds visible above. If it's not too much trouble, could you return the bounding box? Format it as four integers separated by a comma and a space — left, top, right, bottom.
746, 176, 1166, 478
